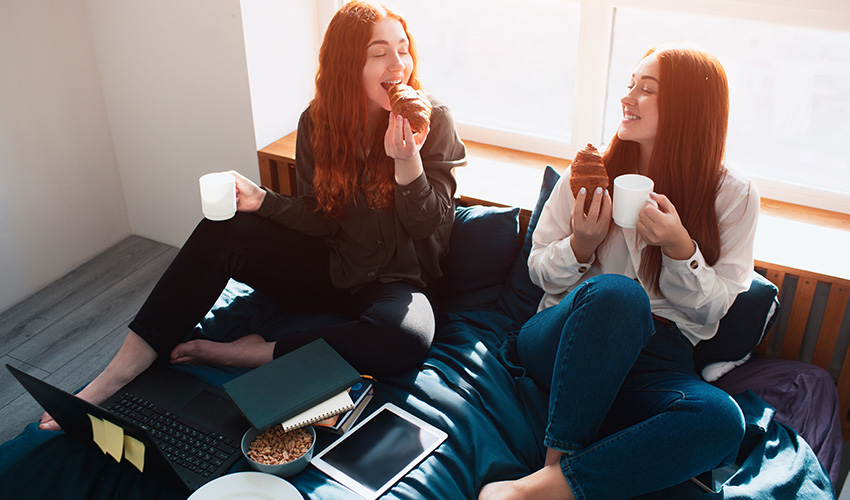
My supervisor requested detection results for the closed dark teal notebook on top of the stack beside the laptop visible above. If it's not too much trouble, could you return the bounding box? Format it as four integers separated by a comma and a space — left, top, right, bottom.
224, 339, 360, 431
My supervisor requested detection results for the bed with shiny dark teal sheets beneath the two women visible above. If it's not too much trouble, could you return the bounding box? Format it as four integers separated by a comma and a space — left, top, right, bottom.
0, 168, 841, 499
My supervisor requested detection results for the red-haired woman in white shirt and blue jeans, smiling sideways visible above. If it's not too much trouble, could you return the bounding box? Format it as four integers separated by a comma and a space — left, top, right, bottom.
479, 45, 759, 500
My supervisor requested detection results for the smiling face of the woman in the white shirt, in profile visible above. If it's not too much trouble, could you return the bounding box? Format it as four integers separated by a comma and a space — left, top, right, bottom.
617, 54, 660, 153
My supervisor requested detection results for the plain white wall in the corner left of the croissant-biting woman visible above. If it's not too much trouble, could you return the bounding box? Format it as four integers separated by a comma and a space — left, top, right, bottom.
0, 0, 327, 311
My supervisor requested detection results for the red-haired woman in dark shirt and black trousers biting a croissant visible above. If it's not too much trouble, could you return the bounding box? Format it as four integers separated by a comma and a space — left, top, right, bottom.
42, 0, 466, 428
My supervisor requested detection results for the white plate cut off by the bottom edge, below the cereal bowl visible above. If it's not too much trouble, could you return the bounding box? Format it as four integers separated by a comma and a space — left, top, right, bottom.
188, 472, 304, 500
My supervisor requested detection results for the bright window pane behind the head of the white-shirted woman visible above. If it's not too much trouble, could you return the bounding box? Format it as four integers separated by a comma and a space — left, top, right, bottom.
604, 8, 850, 213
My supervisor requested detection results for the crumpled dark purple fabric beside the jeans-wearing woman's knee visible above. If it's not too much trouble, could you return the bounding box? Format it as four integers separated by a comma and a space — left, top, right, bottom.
715, 359, 843, 484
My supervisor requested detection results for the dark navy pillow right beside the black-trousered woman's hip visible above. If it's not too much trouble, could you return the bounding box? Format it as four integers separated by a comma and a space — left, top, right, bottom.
436, 205, 520, 311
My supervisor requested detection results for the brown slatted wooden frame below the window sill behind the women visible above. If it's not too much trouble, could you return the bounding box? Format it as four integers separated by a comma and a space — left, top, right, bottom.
258, 133, 850, 440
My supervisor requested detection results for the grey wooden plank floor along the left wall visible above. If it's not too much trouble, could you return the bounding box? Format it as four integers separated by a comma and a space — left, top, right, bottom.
0, 236, 177, 443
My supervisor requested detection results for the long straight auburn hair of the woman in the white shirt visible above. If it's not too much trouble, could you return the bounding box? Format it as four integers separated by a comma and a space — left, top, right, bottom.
604, 45, 729, 291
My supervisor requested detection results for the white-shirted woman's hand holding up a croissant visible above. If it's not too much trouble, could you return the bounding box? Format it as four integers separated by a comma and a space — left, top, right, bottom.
570, 188, 611, 262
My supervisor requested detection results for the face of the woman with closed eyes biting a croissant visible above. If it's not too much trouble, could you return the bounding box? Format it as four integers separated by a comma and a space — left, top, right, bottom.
362, 17, 413, 111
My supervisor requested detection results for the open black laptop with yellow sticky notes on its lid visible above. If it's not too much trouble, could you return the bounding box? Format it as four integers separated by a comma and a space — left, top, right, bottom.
6, 363, 250, 491
